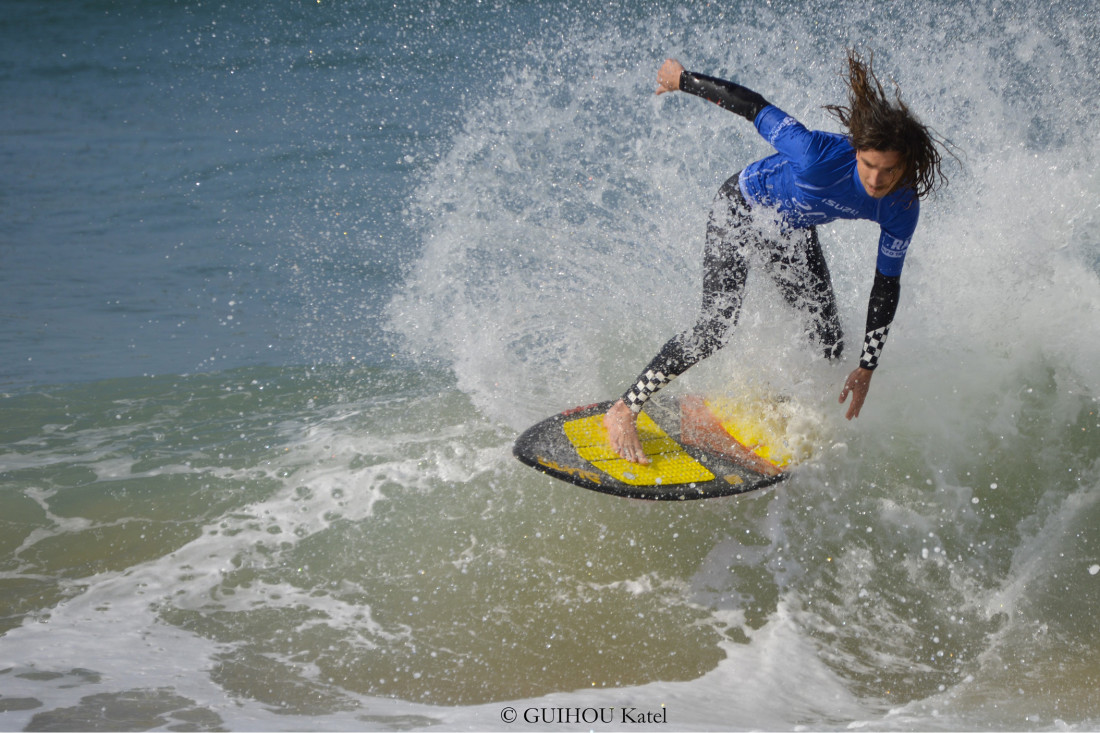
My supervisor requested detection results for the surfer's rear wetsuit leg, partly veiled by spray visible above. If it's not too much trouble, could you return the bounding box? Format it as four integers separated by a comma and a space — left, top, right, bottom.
768, 227, 844, 359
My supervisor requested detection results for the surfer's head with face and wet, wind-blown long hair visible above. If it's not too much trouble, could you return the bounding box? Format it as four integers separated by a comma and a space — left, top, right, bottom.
825, 51, 947, 198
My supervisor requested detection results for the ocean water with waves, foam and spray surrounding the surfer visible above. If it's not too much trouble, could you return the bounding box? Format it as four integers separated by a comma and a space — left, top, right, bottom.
0, 0, 1100, 731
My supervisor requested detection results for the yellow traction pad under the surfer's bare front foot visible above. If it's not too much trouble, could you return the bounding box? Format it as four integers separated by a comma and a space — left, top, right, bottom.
562, 413, 715, 486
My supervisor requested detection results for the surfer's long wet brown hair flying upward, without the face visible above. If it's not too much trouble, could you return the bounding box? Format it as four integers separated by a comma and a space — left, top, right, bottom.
825, 50, 954, 198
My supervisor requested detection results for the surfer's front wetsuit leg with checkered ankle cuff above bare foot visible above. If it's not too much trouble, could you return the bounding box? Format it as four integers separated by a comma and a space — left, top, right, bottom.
623, 175, 758, 413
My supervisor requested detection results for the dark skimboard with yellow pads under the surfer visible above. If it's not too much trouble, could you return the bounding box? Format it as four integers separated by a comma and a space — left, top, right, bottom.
513, 395, 809, 501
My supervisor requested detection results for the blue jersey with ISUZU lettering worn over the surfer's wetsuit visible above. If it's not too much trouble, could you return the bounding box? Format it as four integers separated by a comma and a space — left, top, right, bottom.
740, 105, 921, 277
